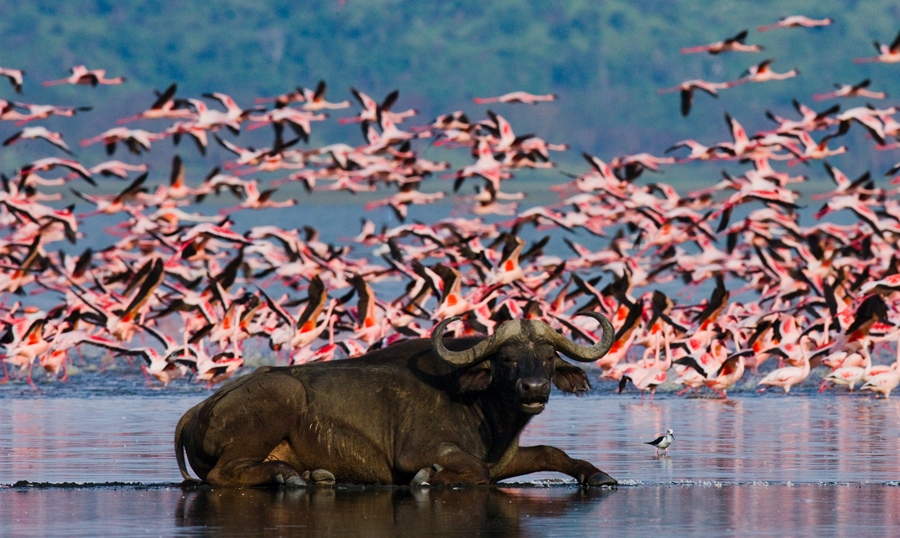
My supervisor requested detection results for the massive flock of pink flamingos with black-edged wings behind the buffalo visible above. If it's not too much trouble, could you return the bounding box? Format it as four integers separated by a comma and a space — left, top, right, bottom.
0, 16, 900, 397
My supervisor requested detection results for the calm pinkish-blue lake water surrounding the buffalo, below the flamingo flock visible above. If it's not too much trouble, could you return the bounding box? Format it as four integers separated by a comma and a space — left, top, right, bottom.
0, 375, 900, 536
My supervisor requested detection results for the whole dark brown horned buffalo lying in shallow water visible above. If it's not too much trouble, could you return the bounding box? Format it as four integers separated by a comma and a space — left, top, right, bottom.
175, 312, 617, 487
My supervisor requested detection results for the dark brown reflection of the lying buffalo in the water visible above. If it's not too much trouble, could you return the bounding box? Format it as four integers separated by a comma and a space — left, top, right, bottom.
175, 488, 614, 536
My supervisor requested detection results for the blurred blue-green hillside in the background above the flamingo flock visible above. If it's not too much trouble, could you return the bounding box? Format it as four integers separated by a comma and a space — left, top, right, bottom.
0, 0, 900, 174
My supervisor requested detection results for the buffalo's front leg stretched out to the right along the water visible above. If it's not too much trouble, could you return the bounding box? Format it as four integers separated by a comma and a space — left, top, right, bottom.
491, 445, 618, 486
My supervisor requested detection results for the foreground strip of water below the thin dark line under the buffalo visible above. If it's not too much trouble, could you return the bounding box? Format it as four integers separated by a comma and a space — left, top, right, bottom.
0, 482, 900, 537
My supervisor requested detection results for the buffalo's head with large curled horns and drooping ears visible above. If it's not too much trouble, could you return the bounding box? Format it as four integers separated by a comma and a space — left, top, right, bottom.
431, 312, 615, 415
